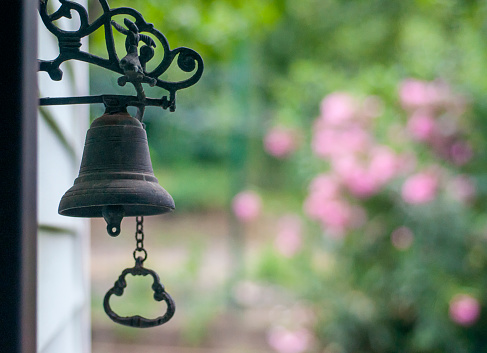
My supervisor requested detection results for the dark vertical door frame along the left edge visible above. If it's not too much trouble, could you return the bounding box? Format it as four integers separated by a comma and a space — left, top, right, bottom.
0, 0, 38, 353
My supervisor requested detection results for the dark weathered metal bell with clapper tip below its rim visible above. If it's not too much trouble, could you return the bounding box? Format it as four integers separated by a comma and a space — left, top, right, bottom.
58, 112, 175, 236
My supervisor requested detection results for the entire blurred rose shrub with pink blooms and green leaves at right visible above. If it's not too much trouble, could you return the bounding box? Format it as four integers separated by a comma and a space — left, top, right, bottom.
265, 79, 487, 353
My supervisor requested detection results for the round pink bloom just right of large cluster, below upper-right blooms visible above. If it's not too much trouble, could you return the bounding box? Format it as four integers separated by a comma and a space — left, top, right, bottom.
401, 172, 438, 204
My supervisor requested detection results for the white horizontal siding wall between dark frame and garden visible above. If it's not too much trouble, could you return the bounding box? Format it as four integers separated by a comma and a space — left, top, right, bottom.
37, 1, 91, 353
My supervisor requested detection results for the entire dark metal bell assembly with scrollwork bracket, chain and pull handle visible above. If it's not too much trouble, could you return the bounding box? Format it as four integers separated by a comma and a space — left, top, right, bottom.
39, 0, 203, 327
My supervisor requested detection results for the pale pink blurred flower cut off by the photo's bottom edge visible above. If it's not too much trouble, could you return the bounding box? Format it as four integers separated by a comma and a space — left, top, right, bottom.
267, 327, 311, 353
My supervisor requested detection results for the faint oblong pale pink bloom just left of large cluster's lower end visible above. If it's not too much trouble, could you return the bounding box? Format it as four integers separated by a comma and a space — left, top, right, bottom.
275, 215, 302, 257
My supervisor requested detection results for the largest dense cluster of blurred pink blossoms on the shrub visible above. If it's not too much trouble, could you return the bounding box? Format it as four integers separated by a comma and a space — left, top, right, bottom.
304, 93, 400, 237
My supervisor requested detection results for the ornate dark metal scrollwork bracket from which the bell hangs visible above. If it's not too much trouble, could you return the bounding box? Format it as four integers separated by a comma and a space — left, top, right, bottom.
39, 0, 203, 115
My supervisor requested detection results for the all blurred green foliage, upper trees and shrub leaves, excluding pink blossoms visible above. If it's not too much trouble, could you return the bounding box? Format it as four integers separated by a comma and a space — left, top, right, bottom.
90, 0, 487, 353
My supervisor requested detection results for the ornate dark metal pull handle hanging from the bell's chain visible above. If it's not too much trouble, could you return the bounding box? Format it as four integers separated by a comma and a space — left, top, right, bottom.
103, 257, 176, 328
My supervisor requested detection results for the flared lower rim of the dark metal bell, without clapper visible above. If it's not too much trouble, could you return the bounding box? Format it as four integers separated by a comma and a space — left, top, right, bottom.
58, 179, 175, 218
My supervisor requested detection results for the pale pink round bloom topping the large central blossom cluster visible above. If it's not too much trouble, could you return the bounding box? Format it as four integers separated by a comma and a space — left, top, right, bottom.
321, 92, 357, 126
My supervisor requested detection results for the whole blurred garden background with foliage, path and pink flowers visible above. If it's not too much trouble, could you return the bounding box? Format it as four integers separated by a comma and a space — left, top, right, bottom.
86, 0, 487, 353
